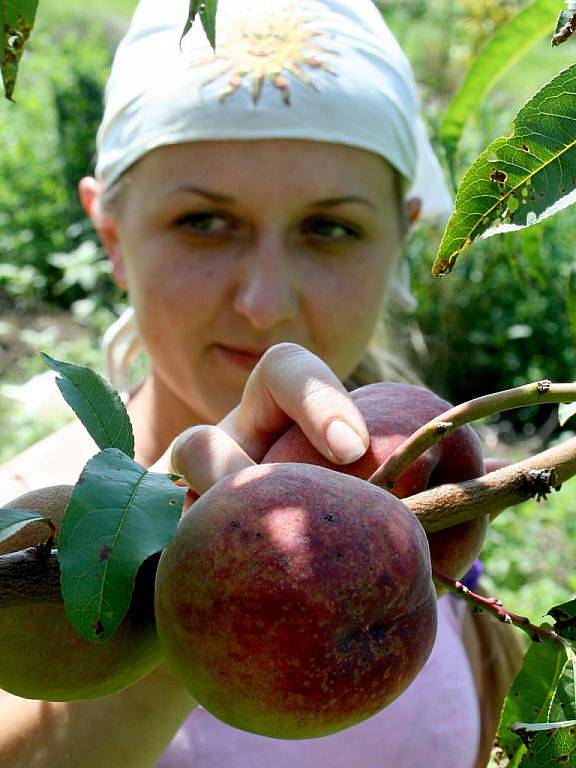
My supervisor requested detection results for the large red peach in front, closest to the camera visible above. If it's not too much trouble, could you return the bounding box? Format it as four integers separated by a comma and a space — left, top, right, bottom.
156, 464, 437, 739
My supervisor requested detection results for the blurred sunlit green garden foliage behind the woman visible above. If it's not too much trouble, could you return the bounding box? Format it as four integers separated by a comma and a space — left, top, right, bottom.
0, 0, 576, 621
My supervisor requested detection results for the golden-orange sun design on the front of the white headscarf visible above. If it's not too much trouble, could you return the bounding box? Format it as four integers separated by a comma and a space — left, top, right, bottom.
198, 1, 336, 104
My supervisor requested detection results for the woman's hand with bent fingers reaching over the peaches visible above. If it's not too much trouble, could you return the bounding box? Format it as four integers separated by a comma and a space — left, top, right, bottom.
166, 343, 370, 494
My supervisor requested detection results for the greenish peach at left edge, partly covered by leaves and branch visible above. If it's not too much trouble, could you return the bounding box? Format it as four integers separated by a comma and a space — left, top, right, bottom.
0, 485, 163, 701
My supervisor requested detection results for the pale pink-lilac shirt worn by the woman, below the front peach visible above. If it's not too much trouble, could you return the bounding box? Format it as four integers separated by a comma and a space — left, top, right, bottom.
157, 596, 480, 768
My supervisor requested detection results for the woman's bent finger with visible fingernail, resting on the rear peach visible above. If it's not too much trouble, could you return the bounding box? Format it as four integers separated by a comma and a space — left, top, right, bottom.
218, 343, 370, 464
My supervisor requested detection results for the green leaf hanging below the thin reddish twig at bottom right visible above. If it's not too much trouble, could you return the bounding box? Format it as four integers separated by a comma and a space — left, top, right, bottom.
496, 643, 573, 766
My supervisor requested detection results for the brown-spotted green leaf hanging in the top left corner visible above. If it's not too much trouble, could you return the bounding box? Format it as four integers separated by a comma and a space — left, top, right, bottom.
0, 0, 38, 99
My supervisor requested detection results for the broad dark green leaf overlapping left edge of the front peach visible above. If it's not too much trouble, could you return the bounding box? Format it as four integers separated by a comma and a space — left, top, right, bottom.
58, 448, 186, 642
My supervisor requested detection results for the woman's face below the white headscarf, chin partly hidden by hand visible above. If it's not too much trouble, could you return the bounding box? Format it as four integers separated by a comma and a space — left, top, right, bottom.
99, 140, 402, 422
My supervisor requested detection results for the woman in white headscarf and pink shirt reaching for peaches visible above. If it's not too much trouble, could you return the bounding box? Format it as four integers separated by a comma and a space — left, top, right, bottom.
0, 0, 520, 768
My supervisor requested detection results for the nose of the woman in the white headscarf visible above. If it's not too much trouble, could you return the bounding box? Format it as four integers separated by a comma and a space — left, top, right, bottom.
234, 237, 298, 331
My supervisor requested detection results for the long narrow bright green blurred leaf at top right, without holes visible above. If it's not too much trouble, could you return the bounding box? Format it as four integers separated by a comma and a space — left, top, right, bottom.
440, 0, 558, 175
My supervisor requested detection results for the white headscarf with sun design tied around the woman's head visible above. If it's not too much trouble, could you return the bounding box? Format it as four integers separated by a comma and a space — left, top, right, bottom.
96, 0, 452, 396
